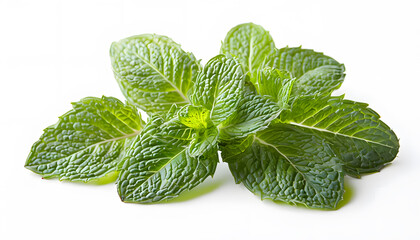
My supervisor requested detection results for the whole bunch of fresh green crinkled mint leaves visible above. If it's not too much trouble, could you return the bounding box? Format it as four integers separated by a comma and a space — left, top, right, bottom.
25, 23, 399, 209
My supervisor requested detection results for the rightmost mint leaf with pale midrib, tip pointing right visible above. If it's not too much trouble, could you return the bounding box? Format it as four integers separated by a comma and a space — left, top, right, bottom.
280, 96, 399, 177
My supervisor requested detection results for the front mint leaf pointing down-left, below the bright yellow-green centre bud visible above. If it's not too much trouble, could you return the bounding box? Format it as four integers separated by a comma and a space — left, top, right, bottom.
117, 116, 218, 203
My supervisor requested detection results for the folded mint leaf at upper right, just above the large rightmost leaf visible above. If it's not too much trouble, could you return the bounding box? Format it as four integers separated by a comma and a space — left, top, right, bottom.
265, 47, 345, 98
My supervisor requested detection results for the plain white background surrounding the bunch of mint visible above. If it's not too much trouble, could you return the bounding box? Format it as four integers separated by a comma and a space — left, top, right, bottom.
0, 0, 420, 240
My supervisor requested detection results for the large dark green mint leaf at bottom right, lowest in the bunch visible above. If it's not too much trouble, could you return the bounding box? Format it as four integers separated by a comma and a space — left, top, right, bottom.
222, 123, 344, 209
